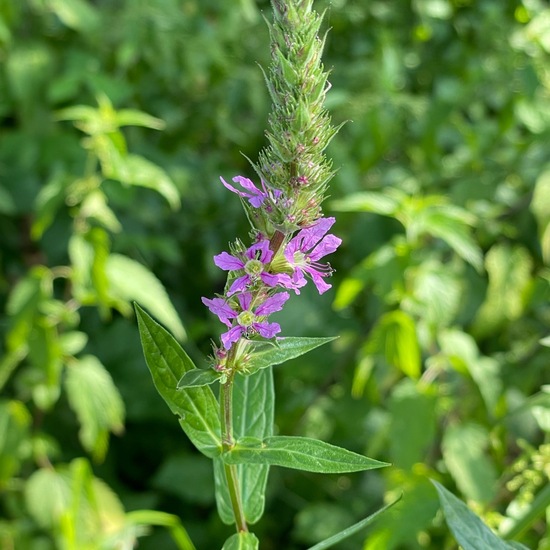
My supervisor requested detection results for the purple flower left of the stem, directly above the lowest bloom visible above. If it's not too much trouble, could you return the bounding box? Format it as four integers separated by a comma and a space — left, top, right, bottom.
214, 240, 281, 296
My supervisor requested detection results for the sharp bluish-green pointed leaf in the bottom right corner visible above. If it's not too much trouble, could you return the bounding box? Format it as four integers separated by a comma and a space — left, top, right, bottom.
431, 480, 526, 550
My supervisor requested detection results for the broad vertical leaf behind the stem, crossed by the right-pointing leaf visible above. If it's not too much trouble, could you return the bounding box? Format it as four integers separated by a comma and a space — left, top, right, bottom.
214, 369, 275, 525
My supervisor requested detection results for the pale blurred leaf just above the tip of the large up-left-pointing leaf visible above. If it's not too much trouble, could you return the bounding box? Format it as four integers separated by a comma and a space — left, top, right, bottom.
106, 254, 185, 340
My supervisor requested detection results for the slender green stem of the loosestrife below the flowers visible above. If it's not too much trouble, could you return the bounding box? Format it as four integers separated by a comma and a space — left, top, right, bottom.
220, 366, 248, 532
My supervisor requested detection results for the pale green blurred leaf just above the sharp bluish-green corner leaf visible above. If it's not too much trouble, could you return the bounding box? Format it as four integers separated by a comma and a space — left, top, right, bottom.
442, 422, 498, 504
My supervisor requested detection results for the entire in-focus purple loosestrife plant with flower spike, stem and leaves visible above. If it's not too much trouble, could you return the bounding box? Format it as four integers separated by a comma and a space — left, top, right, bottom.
136, 0, 396, 550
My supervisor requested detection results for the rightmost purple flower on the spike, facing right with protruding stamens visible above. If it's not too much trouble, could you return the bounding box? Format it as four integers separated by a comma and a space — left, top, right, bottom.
285, 218, 342, 294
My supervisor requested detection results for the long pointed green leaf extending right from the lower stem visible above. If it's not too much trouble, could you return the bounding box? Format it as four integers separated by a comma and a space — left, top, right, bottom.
222, 435, 389, 474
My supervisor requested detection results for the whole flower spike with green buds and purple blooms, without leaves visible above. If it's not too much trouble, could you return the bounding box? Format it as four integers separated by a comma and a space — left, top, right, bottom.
202, 0, 341, 371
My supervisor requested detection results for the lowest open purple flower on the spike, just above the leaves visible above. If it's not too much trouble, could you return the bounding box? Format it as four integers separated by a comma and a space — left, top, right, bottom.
202, 292, 290, 349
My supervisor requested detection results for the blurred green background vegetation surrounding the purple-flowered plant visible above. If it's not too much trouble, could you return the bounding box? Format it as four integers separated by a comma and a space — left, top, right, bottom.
0, 0, 550, 550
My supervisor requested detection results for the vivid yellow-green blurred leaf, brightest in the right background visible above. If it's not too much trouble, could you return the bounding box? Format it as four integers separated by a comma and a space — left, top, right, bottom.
363, 310, 421, 378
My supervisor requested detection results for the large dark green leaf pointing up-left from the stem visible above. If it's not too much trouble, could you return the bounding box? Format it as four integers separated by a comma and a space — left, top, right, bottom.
135, 304, 222, 458
